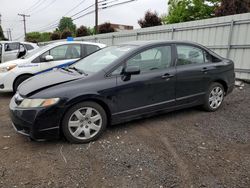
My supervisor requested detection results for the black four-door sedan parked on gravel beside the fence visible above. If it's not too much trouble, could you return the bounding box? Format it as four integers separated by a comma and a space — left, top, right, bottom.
10, 41, 235, 143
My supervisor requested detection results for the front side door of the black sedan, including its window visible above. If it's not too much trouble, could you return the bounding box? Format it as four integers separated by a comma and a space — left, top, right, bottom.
112, 45, 176, 116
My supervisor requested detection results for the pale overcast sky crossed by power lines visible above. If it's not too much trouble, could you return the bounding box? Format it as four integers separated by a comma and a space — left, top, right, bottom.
0, 0, 167, 41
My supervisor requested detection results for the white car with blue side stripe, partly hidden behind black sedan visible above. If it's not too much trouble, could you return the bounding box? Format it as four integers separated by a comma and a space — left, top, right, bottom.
0, 41, 106, 92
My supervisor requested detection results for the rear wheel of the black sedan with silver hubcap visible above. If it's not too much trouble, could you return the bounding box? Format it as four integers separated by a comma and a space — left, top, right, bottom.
203, 82, 225, 112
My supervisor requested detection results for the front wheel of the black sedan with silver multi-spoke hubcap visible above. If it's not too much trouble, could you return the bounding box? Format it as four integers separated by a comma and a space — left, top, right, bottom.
62, 102, 107, 144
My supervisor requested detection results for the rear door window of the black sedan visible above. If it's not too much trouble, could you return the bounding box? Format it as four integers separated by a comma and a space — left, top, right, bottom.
177, 45, 205, 65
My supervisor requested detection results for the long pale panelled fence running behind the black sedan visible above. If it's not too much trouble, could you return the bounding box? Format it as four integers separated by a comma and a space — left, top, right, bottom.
43, 13, 250, 80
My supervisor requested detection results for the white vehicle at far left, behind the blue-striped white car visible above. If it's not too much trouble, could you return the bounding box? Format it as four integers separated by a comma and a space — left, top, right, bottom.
0, 41, 39, 63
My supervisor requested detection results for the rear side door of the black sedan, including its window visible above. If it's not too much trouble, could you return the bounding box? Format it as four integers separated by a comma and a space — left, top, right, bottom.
176, 44, 211, 105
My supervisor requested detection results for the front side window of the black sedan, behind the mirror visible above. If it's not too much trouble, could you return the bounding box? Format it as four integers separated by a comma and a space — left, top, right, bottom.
127, 46, 171, 72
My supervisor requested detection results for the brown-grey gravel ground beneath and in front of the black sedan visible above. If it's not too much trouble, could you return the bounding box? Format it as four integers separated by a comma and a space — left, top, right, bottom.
0, 85, 250, 188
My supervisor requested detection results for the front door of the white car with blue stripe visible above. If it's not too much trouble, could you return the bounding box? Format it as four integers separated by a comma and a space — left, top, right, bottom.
35, 44, 82, 73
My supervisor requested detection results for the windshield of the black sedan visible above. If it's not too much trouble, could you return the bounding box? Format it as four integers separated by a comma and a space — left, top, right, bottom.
71, 45, 136, 74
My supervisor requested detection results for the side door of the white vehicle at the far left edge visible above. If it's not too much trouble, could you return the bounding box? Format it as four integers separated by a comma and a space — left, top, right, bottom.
3, 42, 20, 62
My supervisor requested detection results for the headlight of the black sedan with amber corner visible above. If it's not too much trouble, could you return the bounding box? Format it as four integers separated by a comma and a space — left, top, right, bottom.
19, 98, 59, 108
